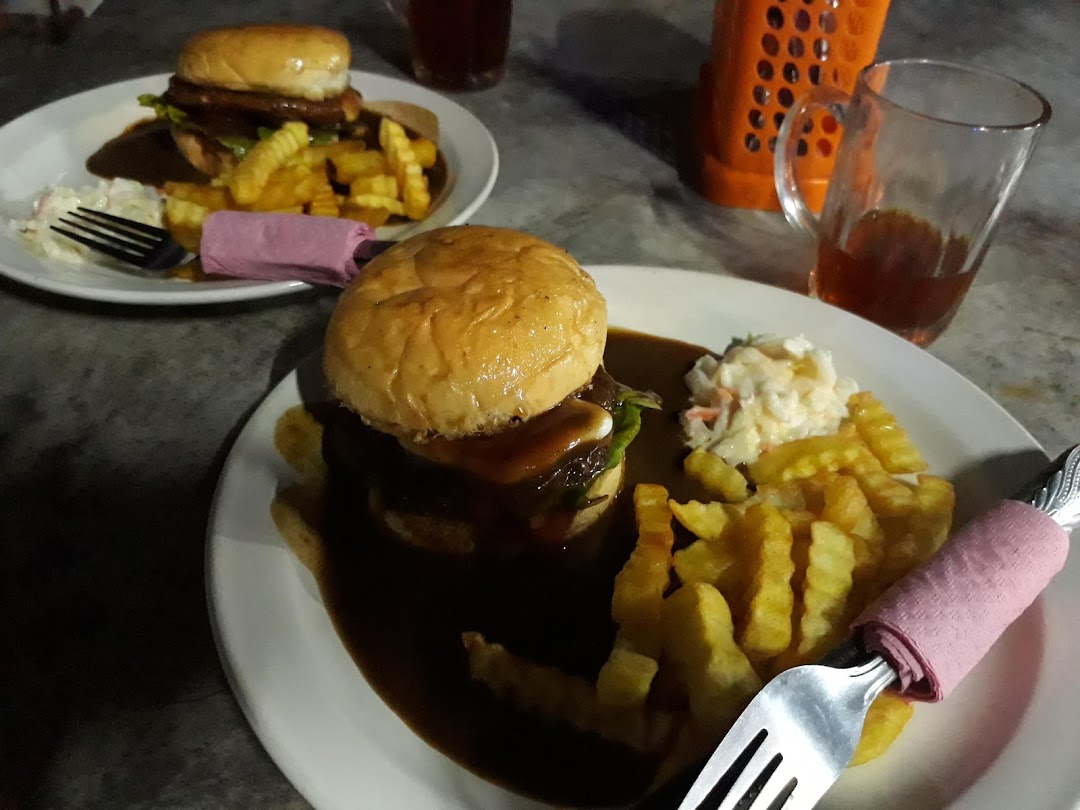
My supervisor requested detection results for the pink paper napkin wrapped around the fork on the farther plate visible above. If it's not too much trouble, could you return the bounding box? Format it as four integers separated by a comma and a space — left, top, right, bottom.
199, 211, 375, 287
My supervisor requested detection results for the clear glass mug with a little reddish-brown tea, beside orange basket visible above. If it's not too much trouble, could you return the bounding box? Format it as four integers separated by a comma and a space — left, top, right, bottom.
774, 59, 1050, 346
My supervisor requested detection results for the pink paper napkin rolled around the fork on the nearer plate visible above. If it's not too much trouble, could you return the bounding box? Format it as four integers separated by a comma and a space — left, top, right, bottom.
852, 501, 1069, 701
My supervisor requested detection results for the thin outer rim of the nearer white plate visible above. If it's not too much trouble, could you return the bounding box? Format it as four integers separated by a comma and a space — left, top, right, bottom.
205, 264, 1080, 808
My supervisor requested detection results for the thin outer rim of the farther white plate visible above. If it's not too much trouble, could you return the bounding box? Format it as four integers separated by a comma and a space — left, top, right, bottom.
0, 69, 500, 307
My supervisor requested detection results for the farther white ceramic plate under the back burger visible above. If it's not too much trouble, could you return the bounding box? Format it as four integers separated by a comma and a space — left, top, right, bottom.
0, 70, 499, 305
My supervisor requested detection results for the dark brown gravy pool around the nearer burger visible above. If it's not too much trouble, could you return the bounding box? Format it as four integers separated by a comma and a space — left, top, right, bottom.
319, 329, 707, 807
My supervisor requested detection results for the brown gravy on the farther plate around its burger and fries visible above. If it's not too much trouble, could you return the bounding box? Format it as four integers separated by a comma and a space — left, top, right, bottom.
86, 113, 449, 207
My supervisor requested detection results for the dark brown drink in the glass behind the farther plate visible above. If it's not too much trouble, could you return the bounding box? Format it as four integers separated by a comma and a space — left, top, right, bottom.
408, 0, 512, 90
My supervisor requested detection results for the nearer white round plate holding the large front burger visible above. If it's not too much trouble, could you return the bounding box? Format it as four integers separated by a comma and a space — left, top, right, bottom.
206, 266, 1080, 810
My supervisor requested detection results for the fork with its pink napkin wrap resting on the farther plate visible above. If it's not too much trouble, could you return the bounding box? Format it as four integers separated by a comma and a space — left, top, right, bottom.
50, 207, 396, 286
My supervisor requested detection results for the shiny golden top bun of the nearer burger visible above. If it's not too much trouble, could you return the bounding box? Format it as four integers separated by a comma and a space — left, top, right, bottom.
323, 226, 607, 441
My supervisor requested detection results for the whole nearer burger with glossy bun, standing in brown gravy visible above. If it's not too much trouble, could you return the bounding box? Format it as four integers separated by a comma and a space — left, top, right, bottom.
323, 227, 659, 553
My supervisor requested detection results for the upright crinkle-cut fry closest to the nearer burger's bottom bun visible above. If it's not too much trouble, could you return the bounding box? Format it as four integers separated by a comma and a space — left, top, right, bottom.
611, 484, 675, 656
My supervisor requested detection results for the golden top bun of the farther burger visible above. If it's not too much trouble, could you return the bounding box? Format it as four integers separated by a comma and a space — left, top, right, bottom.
176, 25, 352, 102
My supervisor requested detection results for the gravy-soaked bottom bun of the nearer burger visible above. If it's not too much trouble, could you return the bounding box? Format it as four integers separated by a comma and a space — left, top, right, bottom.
368, 463, 625, 554
